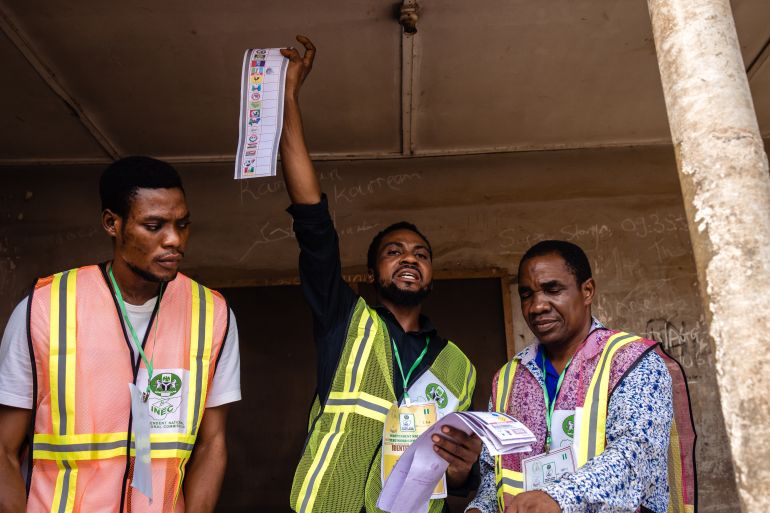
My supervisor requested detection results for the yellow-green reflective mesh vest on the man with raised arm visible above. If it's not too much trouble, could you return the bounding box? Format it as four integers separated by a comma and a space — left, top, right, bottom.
290, 298, 476, 513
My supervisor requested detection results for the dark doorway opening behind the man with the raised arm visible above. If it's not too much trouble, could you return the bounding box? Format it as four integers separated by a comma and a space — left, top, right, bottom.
217, 278, 506, 513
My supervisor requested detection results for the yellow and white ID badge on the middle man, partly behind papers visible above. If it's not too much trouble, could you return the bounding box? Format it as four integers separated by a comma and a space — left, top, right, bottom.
380, 401, 447, 499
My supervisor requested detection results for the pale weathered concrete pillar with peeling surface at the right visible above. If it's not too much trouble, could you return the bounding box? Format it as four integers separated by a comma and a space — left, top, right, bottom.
647, 0, 770, 513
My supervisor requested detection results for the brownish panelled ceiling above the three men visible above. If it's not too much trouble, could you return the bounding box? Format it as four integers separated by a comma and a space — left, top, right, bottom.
0, 0, 770, 164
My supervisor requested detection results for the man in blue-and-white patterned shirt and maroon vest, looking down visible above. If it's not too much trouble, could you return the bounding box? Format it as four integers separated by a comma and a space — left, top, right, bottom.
466, 241, 695, 513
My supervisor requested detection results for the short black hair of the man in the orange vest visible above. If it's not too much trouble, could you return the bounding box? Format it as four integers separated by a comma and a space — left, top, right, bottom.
99, 156, 184, 218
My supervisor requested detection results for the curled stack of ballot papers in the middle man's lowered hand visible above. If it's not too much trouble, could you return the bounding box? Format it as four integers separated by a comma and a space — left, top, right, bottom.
377, 411, 535, 513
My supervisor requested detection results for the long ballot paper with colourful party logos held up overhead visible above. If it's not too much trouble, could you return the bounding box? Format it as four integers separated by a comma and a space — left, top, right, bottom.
235, 48, 289, 180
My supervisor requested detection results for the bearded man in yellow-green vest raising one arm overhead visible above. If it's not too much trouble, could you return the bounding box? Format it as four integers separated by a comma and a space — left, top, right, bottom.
281, 36, 481, 513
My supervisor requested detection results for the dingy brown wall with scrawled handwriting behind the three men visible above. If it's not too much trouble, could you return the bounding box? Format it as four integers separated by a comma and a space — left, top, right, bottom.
0, 143, 738, 512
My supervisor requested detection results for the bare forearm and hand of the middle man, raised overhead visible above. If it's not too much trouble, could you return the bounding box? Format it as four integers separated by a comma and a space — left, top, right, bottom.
281, 36, 321, 205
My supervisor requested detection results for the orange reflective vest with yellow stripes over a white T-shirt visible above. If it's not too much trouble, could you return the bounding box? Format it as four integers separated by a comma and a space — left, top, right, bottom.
27, 266, 228, 513
